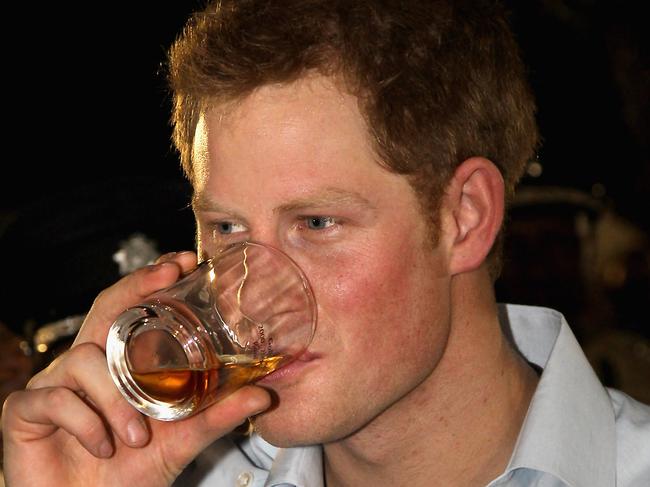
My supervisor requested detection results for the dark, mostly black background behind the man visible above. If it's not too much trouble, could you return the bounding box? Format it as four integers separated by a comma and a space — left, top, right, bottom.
0, 0, 650, 400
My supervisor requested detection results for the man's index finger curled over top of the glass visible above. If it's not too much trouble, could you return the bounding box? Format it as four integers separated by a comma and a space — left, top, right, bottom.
72, 252, 196, 349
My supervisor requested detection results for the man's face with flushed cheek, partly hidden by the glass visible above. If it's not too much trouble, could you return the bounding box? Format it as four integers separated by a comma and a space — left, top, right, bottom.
194, 78, 449, 446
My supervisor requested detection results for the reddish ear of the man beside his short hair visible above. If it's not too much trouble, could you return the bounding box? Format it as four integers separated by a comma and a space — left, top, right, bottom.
445, 157, 504, 275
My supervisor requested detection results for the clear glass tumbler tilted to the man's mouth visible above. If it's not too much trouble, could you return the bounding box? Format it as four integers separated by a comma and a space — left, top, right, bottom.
106, 242, 316, 421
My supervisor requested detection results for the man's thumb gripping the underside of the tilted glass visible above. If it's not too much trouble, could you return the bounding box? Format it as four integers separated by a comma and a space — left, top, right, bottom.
164, 385, 271, 471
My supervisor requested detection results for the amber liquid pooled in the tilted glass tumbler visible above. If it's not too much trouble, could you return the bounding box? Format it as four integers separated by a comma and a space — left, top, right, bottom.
131, 355, 283, 409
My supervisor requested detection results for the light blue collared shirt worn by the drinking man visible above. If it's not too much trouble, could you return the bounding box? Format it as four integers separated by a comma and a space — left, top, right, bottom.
177, 305, 650, 487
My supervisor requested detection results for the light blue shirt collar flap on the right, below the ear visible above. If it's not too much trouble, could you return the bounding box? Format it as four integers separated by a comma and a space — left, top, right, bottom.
502, 305, 616, 487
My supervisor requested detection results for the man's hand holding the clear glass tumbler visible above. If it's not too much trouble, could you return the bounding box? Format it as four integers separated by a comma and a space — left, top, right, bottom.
2, 252, 270, 487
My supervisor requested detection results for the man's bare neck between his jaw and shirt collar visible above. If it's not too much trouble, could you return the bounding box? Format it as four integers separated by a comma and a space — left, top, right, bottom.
324, 274, 537, 487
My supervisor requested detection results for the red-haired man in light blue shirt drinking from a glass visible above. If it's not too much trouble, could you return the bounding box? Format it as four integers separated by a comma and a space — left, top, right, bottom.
3, 0, 650, 487
